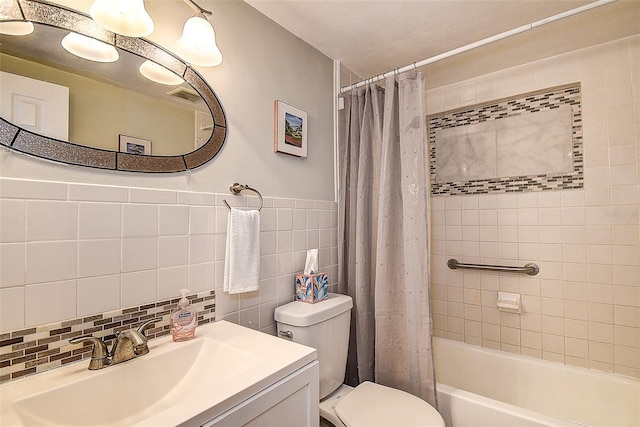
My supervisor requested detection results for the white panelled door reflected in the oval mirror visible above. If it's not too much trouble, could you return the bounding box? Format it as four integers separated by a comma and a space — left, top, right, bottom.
0, 71, 69, 141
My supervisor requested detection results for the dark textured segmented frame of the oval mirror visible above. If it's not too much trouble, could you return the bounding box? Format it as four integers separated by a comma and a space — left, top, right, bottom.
0, 0, 227, 173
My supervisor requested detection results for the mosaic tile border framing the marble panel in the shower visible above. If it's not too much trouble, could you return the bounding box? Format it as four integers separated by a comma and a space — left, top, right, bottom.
427, 83, 584, 195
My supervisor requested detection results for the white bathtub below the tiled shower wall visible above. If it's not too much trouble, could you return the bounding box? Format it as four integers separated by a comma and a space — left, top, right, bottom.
434, 338, 640, 427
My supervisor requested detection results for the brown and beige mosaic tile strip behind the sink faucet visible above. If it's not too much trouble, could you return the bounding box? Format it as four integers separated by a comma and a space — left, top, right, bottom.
0, 290, 216, 383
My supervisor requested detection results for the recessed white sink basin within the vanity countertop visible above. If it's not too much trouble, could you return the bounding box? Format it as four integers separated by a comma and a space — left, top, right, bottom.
15, 338, 260, 426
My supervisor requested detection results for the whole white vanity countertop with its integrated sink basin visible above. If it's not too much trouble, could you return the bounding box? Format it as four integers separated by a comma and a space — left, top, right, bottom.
0, 322, 316, 426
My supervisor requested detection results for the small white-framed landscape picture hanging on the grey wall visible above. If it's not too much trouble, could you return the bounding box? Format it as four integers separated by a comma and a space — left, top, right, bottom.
274, 100, 308, 158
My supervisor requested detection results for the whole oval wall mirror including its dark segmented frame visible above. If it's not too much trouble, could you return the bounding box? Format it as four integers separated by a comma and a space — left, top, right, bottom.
0, 0, 227, 172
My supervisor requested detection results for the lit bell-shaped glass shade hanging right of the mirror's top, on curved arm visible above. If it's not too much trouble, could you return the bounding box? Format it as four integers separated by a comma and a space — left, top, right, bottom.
174, 16, 222, 67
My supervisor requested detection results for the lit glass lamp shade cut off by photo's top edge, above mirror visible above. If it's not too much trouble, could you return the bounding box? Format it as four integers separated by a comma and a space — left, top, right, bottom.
89, 0, 153, 37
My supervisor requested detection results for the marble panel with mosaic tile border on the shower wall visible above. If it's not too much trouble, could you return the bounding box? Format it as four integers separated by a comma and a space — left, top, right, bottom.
429, 84, 584, 195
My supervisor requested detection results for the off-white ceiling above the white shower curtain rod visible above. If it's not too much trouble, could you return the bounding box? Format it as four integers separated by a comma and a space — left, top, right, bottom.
245, 0, 640, 88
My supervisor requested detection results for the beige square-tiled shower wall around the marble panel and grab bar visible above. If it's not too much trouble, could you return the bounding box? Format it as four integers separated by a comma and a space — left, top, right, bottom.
427, 36, 640, 377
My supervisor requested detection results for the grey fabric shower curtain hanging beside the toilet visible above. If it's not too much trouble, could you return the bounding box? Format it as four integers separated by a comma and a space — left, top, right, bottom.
338, 72, 436, 406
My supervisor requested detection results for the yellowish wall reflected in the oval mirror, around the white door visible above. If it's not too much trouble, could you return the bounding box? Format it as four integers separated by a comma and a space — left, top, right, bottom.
0, 54, 200, 155
